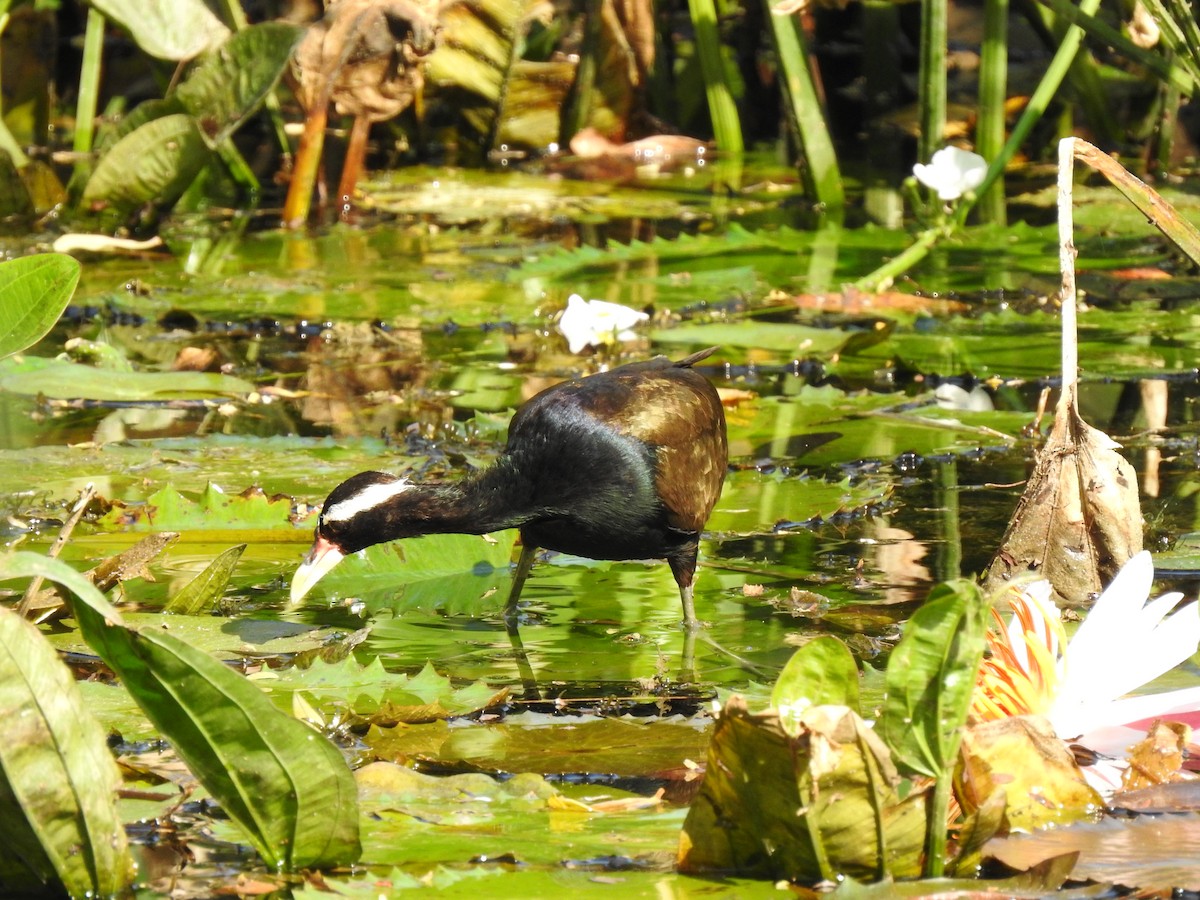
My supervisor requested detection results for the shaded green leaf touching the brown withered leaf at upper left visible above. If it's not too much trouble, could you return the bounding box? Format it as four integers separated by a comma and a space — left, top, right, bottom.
175, 22, 304, 146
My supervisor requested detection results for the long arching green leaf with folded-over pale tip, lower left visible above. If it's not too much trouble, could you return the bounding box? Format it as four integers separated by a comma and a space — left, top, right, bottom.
6, 553, 360, 870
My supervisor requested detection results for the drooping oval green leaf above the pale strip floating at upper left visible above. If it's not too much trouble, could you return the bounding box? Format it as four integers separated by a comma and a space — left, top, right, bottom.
83, 113, 210, 212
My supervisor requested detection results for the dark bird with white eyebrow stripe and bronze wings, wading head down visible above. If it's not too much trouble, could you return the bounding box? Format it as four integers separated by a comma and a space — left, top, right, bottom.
292, 347, 728, 626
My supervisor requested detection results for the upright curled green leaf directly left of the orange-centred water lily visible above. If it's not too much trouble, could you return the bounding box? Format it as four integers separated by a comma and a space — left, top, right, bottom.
876, 580, 988, 778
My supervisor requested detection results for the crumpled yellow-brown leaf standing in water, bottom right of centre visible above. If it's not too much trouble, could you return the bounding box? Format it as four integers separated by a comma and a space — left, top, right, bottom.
679, 695, 926, 882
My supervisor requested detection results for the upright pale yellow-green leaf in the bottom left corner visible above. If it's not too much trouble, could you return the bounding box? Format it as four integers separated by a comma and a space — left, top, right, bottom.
0, 600, 133, 896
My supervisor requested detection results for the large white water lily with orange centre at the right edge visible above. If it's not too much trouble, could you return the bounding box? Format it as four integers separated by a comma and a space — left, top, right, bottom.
971, 551, 1200, 772
